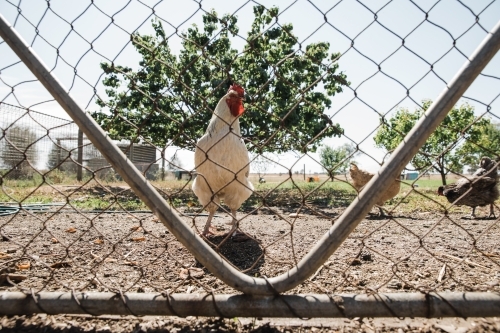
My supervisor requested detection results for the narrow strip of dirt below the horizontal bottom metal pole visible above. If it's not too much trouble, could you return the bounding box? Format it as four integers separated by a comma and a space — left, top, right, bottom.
0, 314, 500, 333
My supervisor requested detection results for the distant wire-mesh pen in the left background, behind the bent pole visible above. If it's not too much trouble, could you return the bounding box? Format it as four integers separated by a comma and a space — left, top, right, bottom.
0, 103, 162, 183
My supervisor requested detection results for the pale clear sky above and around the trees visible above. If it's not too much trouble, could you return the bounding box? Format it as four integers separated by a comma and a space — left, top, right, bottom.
0, 0, 500, 172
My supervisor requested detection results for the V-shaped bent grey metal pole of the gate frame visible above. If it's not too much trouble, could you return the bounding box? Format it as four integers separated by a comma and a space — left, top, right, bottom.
0, 14, 500, 295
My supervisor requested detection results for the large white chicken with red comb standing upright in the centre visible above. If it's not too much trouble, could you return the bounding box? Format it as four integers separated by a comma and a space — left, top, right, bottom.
192, 84, 254, 236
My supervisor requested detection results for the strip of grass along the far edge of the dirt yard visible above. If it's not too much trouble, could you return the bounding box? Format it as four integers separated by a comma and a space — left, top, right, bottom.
0, 175, 496, 214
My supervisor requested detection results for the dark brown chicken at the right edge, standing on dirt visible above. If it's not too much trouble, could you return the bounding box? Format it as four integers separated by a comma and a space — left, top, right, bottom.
438, 157, 499, 218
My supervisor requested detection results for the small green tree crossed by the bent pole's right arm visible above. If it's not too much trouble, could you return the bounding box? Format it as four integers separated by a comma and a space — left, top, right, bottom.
373, 100, 489, 185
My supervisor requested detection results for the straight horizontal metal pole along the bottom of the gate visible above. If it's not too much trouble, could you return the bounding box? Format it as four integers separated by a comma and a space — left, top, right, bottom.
0, 292, 500, 318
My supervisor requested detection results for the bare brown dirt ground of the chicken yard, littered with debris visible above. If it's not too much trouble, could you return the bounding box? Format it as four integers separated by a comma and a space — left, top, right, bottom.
0, 207, 500, 332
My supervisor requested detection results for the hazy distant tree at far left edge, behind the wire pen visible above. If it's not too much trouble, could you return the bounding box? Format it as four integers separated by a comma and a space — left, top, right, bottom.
0, 126, 38, 178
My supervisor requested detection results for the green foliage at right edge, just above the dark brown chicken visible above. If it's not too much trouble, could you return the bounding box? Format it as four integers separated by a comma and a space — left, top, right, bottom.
459, 122, 500, 169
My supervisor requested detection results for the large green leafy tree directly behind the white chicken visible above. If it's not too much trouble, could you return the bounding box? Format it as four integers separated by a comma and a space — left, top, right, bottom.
93, 5, 349, 153
